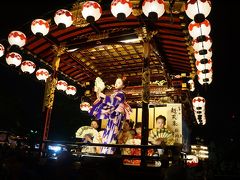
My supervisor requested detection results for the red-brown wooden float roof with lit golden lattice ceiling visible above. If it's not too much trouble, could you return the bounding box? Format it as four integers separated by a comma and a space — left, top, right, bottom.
0, 0, 196, 95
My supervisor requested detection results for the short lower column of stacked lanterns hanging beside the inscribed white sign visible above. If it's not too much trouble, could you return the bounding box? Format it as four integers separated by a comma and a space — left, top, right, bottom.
192, 96, 206, 125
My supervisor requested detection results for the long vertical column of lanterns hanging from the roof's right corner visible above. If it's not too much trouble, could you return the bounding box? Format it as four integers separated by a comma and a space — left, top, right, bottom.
185, 0, 213, 85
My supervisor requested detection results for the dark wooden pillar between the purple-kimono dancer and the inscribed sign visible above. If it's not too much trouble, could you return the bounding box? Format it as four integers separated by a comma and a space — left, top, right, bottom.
141, 40, 150, 166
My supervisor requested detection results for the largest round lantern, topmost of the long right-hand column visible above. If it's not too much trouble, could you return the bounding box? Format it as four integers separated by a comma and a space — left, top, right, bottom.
185, 0, 211, 23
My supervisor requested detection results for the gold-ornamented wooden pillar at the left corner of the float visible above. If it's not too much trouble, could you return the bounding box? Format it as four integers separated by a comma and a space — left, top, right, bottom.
40, 46, 66, 154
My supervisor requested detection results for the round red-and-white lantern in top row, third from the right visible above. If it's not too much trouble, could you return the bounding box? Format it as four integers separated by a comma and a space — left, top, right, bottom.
111, 0, 132, 21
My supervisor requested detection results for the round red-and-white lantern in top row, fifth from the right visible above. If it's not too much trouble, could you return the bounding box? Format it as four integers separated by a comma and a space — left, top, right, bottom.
54, 9, 73, 28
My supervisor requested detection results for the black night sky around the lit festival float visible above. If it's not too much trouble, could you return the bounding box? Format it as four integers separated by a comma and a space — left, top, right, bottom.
0, 0, 240, 142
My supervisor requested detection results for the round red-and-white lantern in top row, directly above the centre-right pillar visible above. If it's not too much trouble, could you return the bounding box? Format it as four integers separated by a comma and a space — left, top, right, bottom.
142, 0, 165, 21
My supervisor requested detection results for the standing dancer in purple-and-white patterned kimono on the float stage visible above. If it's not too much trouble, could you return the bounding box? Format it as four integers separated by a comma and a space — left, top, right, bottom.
90, 78, 131, 154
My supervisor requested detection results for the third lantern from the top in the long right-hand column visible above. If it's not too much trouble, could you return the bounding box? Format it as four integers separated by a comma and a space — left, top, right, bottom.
192, 36, 212, 51
